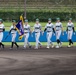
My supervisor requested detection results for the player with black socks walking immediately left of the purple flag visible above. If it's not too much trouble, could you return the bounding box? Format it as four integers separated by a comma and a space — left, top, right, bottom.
9, 20, 19, 49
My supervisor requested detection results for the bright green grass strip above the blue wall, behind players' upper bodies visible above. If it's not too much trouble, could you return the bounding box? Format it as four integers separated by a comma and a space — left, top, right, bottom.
4, 22, 76, 31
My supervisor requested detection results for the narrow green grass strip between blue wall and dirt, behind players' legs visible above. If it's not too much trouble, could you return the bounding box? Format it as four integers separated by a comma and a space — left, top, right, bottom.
3, 42, 76, 46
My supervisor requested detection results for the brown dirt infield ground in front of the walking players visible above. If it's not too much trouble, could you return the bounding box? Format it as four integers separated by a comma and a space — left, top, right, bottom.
0, 47, 76, 75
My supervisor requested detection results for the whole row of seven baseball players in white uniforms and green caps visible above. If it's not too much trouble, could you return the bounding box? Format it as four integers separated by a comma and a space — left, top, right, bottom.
0, 18, 75, 49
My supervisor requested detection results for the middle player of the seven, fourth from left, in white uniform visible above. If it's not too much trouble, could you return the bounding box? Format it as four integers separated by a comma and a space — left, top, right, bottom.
34, 19, 42, 49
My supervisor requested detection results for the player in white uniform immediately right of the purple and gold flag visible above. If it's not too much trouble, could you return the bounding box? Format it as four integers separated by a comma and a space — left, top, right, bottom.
24, 19, 31, 49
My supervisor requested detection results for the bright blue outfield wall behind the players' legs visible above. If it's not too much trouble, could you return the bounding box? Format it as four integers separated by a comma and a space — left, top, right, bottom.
3, 31, 76, 42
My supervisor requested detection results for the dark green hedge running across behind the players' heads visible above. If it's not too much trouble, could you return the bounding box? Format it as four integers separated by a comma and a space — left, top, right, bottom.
0, 9, 76, 22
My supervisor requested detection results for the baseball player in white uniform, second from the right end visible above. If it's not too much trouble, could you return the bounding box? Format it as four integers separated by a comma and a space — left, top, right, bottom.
55, 18, 63, 48
